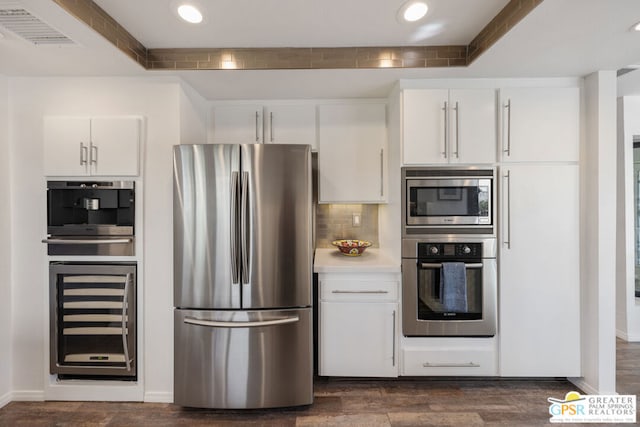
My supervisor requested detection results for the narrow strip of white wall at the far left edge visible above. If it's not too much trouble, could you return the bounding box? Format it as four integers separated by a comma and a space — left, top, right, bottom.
0, 76, 11, 407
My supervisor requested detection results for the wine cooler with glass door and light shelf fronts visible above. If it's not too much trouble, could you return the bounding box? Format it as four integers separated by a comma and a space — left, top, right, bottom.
49, 262, 136, 380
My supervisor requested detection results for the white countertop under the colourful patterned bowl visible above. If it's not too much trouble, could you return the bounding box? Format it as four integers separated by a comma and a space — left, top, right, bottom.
313, 248, 400, 273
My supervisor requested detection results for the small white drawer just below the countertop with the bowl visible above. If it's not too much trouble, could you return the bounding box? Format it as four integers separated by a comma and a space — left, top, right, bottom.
320, 280, 398, 301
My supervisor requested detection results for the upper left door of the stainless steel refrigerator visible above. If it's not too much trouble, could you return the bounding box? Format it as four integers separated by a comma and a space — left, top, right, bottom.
173, 144, 240, 309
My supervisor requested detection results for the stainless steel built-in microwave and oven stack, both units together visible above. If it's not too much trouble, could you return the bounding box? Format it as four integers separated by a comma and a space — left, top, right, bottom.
402, 167, 498, 337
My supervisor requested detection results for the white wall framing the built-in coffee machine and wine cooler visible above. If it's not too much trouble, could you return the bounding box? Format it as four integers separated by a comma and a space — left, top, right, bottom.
8, 78, 186, 401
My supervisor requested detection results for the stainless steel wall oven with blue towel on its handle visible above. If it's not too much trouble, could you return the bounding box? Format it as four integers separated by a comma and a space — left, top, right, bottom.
402, 236, 497, 337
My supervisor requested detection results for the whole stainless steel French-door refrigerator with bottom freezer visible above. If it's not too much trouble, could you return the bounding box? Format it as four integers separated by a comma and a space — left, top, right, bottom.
173, 144, 313, 408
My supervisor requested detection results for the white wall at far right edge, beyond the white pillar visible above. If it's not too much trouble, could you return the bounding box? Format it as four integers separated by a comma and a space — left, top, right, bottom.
616, 96, 640, 341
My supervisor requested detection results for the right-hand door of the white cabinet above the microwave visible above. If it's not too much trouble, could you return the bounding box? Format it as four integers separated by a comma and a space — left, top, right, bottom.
449, 89, 498, 163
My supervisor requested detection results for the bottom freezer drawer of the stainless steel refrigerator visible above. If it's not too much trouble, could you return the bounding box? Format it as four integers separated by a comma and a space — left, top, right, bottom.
174, 308, 313, 409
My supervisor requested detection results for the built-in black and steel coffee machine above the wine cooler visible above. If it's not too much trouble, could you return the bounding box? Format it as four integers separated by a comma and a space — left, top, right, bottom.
42, 181, 135, 256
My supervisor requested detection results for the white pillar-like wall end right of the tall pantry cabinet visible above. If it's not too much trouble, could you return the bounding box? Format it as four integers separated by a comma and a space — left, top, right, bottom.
573, 71, 616, 394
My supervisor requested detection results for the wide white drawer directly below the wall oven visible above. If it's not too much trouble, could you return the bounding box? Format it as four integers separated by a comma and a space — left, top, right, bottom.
402, 348, 498, 376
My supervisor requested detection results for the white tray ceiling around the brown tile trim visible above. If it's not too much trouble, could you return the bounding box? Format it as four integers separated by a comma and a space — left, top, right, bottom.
0, 0, 640, 99
